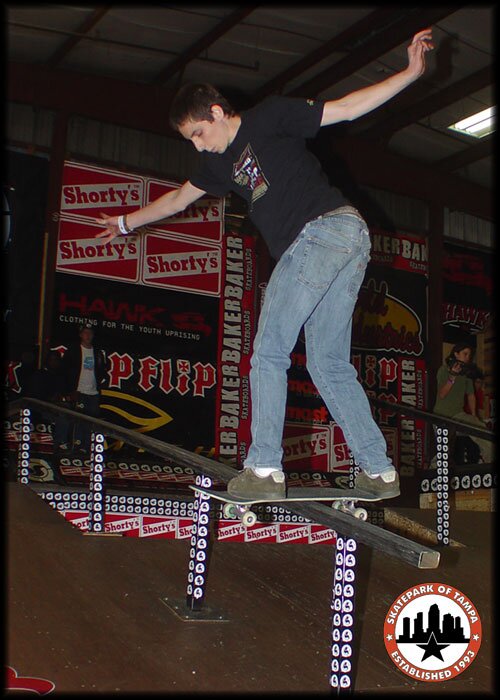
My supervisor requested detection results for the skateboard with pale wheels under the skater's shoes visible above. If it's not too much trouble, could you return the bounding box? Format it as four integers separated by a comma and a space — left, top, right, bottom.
190, 486, 382, 527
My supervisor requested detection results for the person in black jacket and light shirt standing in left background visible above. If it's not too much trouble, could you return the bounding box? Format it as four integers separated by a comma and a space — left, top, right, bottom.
59, 324, 107, 453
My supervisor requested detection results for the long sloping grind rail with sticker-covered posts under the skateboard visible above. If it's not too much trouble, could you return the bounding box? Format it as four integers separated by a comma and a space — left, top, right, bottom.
7, 398, 440, 694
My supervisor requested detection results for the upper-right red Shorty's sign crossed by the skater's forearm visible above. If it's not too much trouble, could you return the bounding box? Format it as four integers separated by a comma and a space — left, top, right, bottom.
145, 180, 224, 243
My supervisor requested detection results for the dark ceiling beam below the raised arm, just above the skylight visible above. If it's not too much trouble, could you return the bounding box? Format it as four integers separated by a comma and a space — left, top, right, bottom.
358, 66, 493, 140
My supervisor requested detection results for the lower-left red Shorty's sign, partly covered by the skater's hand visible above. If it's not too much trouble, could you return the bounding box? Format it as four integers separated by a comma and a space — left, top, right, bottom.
56, 219, 140, 282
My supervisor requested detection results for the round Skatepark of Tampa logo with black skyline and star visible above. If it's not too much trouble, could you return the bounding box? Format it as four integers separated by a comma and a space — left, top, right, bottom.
384, 583, 481, 682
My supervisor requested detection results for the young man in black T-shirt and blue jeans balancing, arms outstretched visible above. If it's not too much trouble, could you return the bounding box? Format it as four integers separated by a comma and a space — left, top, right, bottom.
98, 29, 433, 498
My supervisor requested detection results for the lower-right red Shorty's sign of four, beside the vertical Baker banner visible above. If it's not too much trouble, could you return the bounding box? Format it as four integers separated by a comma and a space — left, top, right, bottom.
142, 233, 221, 296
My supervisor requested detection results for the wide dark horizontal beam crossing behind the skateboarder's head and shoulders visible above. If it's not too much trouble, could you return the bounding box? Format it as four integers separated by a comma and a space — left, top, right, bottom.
7, 62, 492, 219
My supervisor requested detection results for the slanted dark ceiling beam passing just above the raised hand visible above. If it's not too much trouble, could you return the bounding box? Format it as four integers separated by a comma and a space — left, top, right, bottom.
287, 5, 463, 97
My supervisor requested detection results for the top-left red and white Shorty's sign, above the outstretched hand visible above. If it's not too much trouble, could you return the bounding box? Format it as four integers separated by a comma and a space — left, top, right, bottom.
61, 161, 144, 219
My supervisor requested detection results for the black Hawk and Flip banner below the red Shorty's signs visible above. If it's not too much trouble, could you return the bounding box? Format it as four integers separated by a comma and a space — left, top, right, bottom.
52, 275, 219, 447
